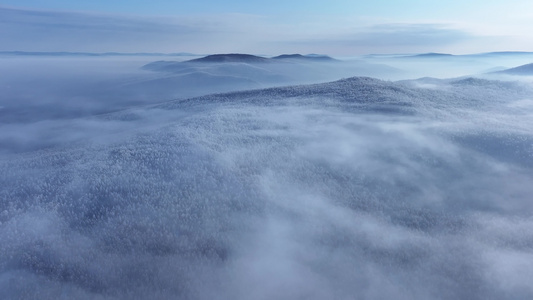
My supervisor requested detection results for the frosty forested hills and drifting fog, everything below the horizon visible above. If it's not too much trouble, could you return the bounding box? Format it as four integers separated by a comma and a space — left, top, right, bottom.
0, 52, 533, 299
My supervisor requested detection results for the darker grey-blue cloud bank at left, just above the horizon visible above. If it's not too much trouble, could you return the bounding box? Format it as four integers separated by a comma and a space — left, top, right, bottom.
0, 8, 239, 52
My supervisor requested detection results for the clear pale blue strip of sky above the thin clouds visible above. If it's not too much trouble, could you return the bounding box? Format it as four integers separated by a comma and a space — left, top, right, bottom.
2, 0, 516, 17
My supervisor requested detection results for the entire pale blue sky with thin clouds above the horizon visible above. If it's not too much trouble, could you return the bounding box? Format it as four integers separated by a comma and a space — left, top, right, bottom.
0, 0, 533, 55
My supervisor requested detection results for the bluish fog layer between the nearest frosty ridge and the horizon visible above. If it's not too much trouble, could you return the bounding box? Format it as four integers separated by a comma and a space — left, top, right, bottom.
0, 54, 533, 123
